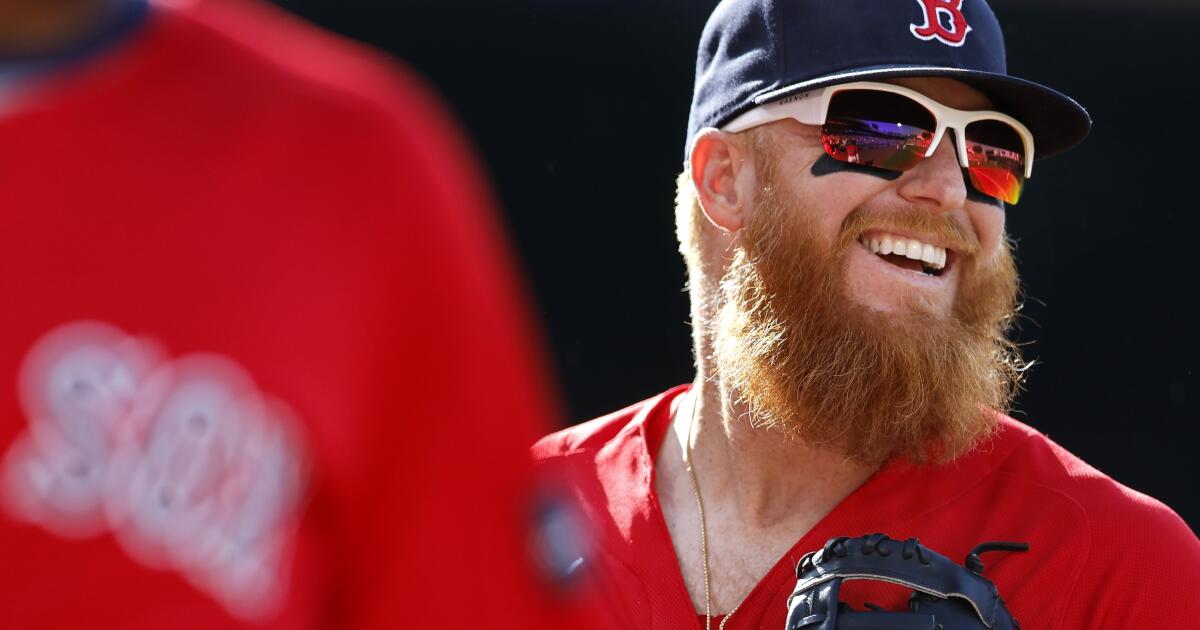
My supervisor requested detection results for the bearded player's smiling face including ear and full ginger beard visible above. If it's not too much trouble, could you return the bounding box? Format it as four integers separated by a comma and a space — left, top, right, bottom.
682, 79, 1020, 462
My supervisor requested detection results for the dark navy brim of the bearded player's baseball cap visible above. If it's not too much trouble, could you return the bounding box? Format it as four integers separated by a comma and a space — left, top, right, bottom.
754, 65, 1092, 158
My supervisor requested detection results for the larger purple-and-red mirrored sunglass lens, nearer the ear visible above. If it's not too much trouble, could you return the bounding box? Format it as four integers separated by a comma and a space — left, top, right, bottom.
821, 90, 937, 170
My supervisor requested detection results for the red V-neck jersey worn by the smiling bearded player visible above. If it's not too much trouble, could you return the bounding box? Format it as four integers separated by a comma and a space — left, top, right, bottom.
534, 386, 1200, 630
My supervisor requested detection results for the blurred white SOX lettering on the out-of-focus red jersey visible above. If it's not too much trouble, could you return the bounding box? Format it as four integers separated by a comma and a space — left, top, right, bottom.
2, 322, 306, 619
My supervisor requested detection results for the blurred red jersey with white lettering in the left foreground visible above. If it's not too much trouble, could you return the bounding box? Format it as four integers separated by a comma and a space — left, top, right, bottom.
0, 1, 580, 630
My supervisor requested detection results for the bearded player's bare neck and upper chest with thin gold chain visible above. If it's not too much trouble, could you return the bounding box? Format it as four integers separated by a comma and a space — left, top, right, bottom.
655, 260, 874, 614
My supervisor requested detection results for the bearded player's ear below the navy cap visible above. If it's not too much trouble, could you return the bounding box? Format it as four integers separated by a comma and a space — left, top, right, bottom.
689, 127, 755, 233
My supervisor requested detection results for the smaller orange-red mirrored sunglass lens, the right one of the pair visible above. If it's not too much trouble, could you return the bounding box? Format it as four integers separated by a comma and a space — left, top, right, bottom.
966, 120, 1025, 204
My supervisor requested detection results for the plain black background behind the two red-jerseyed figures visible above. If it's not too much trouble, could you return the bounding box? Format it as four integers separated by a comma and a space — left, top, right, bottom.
278, 0, 1200, 530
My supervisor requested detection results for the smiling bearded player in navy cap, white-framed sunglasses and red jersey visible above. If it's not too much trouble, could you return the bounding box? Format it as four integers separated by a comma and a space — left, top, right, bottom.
534, 0, 1200, 630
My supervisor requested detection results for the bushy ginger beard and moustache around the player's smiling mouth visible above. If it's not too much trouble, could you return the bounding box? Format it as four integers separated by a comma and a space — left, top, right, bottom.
713, 158, 1021, 463
